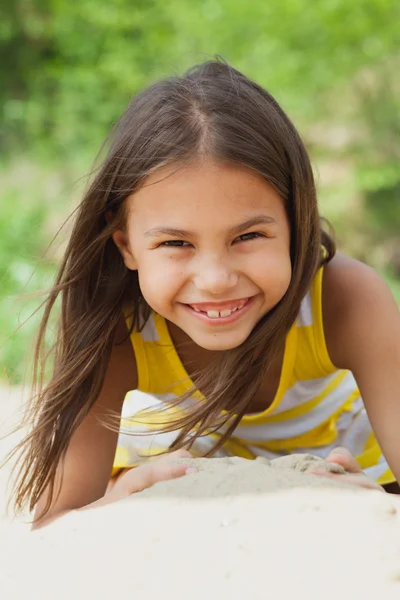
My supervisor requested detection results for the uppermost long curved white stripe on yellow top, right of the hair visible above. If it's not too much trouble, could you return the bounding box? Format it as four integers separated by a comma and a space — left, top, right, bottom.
234, 373, 354, 443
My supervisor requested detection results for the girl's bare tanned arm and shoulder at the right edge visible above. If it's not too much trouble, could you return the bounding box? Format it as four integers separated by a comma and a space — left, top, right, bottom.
323, 255, 400, 481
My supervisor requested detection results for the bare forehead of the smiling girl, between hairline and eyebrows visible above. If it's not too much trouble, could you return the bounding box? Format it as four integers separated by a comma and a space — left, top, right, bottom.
129, 160, 284, 224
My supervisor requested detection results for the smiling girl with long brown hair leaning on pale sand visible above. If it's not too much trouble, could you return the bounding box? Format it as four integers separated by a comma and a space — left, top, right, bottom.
10, 56, 400, 523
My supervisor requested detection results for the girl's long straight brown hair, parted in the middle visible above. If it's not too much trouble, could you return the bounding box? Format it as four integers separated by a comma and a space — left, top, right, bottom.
9, 60, 335, 510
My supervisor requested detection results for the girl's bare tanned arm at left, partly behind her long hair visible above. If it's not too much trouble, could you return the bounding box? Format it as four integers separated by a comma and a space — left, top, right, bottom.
34, 318, 137, 527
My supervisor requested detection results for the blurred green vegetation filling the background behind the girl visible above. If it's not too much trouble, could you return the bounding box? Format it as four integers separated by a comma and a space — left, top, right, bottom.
0, 0, 400, 382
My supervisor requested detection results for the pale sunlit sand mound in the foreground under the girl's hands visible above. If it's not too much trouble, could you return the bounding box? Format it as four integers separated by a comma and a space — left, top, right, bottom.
0, 384, 400, 600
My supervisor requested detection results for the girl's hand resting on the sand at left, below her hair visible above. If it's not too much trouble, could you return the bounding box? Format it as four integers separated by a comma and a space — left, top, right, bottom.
106, 450, 197, 501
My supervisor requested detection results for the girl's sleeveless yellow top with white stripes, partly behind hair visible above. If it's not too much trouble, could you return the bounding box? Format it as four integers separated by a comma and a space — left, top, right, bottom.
113, 268, 395, 485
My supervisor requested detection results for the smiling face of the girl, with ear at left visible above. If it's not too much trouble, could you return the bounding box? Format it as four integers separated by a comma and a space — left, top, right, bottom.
113, 160, 291, 350
